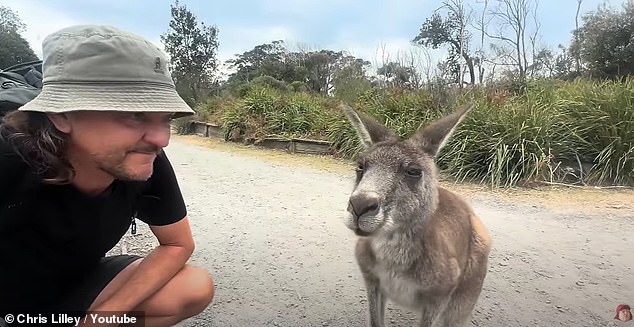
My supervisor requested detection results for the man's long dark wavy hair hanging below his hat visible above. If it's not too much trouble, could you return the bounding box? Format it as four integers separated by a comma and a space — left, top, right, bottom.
0, 110, 75, 184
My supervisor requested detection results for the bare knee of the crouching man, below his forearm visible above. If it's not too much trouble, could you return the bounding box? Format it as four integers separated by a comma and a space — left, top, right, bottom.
178, 265, 215, 316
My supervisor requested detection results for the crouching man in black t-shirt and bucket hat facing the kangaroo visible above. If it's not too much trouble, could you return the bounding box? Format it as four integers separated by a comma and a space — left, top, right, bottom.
0, 25, 214, 326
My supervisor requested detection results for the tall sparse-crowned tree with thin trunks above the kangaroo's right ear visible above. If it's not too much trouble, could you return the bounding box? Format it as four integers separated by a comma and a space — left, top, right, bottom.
412, 0, 476, 85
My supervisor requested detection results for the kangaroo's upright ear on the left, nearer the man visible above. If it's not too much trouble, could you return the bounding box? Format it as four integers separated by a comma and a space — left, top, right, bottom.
339, 103, 397, 148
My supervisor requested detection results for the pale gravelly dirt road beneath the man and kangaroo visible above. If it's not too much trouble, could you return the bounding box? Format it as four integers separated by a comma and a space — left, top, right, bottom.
113, 136, 634, 327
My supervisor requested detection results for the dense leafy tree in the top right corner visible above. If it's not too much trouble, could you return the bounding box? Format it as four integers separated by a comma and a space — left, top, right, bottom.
571, 1, 634, 79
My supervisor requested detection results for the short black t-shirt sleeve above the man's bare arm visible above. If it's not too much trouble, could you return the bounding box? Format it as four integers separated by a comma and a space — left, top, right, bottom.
137, 152, 187, 226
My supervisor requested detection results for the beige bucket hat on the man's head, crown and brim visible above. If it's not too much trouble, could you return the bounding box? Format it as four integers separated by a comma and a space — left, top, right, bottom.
18, 25, 194, 117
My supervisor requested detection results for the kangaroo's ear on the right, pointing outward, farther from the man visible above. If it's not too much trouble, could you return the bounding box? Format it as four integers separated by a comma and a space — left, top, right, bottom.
409, 103, 473, 157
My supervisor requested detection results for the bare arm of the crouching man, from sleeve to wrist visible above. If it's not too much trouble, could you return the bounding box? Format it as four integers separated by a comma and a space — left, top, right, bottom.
91, 217, 195, 312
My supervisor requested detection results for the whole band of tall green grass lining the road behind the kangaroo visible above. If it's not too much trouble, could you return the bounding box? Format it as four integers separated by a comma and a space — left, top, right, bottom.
186, 78, 634, 187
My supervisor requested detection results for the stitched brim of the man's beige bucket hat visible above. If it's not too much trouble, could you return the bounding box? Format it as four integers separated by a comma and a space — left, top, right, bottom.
18, 83, 195, 118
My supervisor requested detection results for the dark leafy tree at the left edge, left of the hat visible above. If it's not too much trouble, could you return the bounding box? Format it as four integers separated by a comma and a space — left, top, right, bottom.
0, 6, 39, 69
